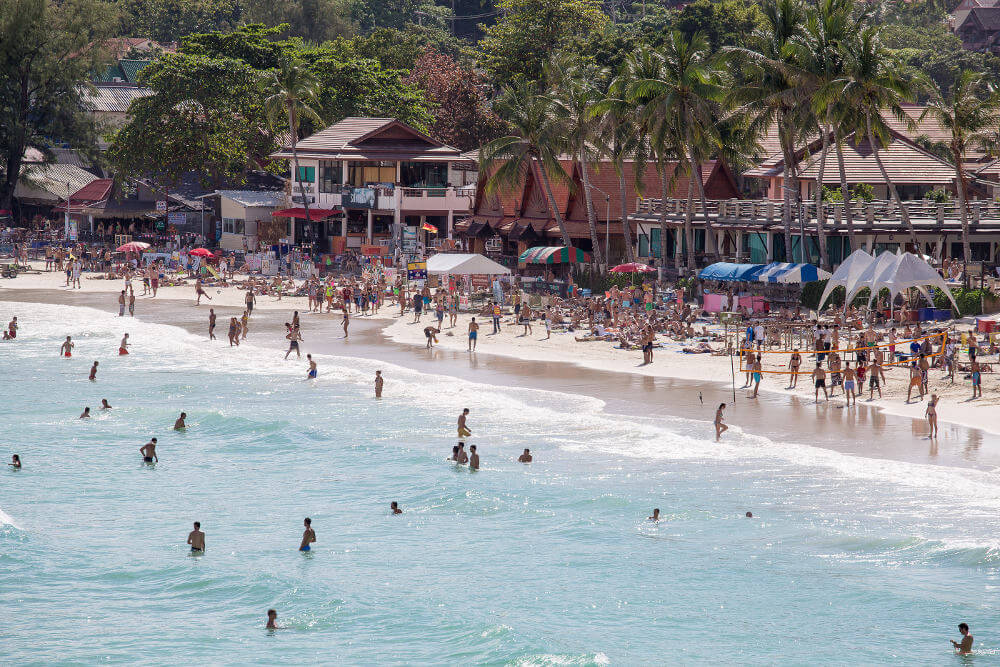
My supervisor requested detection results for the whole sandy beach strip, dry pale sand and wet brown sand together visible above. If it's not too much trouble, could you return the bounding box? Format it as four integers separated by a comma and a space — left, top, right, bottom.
0, 264, 1000, 468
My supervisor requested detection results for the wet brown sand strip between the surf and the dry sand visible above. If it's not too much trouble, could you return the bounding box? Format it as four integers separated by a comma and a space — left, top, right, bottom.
0, 289, 1000, 469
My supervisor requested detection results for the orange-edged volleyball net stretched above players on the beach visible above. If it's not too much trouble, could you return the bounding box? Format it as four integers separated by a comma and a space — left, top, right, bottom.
739, 331, 948, 375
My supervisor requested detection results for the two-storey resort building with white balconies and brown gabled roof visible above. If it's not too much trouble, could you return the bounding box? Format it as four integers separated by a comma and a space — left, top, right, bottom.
271, 117, 477, 254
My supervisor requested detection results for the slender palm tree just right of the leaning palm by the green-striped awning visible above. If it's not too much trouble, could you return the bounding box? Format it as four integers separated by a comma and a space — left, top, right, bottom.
546, 61, 605, 264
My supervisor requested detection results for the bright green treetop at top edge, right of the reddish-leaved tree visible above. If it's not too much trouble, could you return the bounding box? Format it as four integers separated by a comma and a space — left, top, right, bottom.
478, 0, 608, 85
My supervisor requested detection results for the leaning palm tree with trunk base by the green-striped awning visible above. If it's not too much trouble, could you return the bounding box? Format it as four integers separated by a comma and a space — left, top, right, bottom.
480, 81, 572, 246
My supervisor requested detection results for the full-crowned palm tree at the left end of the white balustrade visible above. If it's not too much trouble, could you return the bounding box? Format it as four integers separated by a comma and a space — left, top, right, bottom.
629, 30, 724, 272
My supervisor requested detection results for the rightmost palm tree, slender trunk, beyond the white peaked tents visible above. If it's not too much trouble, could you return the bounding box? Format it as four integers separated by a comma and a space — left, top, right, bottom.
920, 70, 1000, 263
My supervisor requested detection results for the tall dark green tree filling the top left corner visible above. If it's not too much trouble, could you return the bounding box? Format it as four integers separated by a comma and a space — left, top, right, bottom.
0, 0, 115, 209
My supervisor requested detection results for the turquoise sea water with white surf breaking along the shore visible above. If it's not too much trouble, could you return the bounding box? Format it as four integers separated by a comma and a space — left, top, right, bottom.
0, 303, 1000, 665
